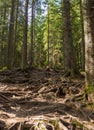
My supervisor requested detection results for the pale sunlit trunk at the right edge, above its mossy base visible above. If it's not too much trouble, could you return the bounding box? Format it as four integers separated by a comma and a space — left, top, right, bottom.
82, 0, 94, 87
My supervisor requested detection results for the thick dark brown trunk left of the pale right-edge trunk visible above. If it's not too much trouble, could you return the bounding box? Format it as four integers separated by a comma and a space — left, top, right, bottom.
63, 0, 77, 73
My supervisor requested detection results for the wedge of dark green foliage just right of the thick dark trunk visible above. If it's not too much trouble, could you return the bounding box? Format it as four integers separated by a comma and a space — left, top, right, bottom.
71, 0, 82, 69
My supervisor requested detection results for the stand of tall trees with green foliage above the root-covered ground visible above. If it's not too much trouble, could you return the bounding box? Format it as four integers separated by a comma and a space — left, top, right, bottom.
0, 0, 94, 92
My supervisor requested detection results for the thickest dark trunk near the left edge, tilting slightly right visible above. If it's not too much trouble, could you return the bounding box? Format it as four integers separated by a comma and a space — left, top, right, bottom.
7, 0, 15, 69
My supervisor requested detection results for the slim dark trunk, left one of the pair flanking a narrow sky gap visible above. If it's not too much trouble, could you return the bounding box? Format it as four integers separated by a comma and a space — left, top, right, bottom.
22, 0, 29, 69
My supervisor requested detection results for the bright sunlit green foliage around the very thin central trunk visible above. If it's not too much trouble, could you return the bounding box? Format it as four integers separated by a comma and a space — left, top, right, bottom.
43, 0, 62, 67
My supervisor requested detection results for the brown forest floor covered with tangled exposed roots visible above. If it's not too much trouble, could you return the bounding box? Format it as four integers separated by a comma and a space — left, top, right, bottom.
0, 69, 94, 130
